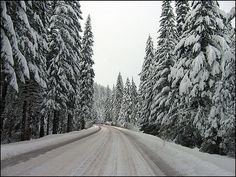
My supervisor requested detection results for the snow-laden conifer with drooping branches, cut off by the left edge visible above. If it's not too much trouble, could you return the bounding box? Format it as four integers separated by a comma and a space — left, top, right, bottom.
0, 1, 30, 134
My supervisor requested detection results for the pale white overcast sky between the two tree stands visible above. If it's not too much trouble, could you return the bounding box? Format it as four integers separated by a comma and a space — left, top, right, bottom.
80, 1, 235, 87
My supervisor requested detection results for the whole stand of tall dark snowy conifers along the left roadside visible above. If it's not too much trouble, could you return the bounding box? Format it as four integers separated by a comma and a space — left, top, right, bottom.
0, 1, 95, 143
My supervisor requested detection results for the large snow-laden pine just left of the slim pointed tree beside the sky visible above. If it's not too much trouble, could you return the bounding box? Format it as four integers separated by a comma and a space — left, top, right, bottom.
46, 1, 83, 133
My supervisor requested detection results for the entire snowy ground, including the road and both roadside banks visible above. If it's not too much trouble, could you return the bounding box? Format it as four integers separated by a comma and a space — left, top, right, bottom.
1, 126, 235, 176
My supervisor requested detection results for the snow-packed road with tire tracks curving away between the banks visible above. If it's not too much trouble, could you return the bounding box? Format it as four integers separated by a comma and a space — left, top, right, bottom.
1, 126, 180, 176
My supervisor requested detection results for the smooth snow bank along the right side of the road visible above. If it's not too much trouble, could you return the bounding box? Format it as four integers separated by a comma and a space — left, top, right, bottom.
117, 128, 235, 176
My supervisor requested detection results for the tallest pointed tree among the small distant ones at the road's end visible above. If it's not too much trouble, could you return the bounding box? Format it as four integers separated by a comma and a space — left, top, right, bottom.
112, 73, 124, 125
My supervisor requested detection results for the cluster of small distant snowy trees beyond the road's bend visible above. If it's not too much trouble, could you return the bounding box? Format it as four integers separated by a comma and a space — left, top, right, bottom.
94, 73, 138, 126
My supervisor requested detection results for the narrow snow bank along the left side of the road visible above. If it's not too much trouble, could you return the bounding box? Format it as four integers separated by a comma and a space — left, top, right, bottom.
1, 126, 100, 160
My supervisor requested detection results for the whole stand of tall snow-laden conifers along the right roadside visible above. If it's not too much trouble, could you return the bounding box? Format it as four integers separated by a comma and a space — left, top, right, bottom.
139, 1, 235, 155
